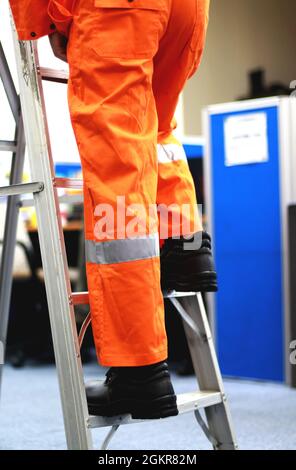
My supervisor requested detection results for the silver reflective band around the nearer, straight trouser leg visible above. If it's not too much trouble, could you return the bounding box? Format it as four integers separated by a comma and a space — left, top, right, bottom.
85, 233, 159, 264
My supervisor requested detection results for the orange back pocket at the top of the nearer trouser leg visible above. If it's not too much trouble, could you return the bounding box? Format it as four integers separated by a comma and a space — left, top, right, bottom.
94, 0, 168, 59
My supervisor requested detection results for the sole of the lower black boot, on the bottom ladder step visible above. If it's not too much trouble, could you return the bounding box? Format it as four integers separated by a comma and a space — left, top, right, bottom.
88, 395, 179, 419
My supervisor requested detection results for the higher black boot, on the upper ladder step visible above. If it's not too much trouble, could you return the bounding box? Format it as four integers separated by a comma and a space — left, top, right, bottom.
160, 232, 218, 292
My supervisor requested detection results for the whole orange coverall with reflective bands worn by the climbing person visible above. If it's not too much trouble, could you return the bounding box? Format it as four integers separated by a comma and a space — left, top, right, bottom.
10, 0, 209, 366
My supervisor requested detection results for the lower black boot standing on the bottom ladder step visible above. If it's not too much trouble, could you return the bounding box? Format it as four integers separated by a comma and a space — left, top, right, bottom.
86, 362, 178, 419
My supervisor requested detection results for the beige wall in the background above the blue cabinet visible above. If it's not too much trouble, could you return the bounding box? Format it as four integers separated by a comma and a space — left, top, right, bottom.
184, 0, 296, 134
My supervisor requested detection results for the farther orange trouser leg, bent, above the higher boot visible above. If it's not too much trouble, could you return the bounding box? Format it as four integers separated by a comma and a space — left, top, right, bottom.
153, 0, 209, 236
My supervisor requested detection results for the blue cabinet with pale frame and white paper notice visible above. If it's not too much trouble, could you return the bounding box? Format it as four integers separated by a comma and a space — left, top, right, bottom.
204, 98, 296, 381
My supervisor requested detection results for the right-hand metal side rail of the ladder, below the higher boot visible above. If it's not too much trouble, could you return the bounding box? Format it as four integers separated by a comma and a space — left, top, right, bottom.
180, 294, 237, 450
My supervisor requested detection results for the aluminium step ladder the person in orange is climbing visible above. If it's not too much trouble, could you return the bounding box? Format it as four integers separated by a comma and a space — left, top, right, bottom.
0, 21, 237, 450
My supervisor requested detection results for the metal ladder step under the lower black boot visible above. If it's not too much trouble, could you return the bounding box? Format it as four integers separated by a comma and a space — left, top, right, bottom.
88, 391, 222, 428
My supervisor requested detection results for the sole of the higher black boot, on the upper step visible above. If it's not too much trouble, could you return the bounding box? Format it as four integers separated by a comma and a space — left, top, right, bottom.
162, 271, 218, 292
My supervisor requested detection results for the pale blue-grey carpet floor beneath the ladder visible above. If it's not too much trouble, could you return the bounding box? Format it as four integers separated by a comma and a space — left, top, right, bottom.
0, 364, 296, 450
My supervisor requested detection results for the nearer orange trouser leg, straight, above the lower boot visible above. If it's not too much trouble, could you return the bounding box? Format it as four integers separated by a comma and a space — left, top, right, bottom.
68, 0, 171, 366
